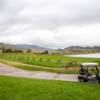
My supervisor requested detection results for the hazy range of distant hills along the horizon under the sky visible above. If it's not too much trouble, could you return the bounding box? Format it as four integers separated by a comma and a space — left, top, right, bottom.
0, 43, 100, 54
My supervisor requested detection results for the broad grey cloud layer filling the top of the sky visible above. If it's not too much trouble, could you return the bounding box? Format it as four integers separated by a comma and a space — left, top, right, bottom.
0, 0, 100, 28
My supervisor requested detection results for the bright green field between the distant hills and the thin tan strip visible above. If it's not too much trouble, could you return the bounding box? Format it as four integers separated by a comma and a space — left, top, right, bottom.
0, 53, 100, 68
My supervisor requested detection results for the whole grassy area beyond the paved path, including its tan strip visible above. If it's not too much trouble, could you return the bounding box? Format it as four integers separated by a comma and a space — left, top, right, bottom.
0, 53, 100, 74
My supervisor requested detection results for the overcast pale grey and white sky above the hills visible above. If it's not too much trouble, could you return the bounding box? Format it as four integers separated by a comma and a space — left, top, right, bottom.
0, 0, 100, 48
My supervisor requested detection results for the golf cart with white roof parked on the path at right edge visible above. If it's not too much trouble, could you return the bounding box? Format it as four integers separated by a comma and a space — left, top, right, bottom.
78, 63, 100, 83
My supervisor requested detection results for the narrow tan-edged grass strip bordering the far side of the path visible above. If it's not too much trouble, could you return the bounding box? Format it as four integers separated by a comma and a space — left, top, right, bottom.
0, 60, 79, 74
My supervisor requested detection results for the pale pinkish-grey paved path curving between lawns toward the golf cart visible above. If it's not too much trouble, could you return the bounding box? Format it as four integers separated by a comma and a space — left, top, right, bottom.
0, 63, 77, 81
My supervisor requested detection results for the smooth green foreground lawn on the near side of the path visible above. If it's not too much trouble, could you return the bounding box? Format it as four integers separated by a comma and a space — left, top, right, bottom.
0, 76, 100, 100
